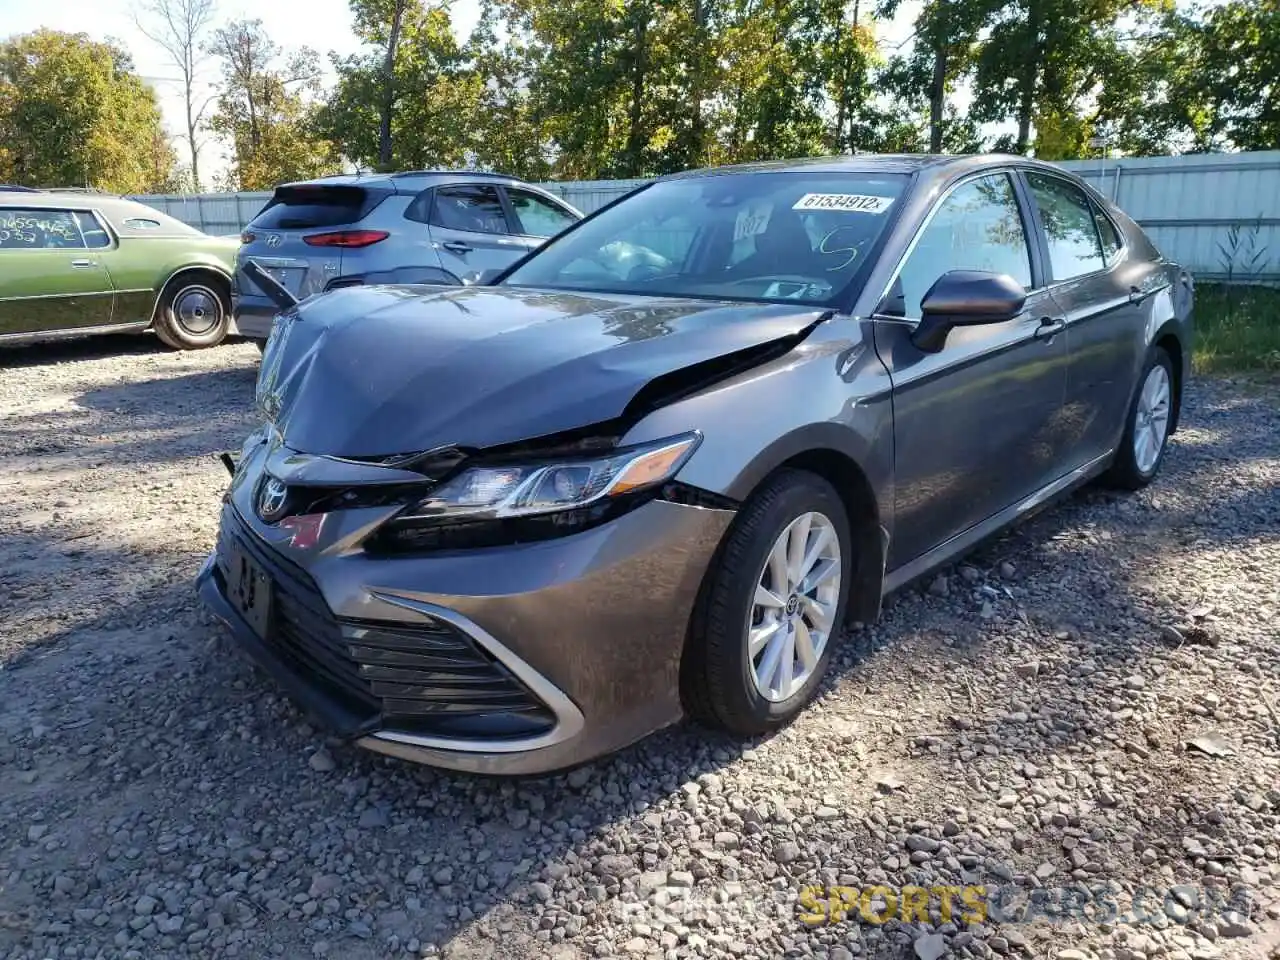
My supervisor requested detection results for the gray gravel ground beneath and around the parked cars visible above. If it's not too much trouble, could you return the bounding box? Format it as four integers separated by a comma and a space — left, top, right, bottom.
0, 339, 1280, 960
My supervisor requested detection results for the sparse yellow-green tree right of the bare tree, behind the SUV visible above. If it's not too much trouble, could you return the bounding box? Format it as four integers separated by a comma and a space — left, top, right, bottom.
209, 20, 340, 189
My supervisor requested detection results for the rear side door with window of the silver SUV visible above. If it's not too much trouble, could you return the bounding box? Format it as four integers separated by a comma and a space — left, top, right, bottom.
428, 183, 527, 280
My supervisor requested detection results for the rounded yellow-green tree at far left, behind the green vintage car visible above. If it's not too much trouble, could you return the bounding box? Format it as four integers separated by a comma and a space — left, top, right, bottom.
0, 29, 174, 193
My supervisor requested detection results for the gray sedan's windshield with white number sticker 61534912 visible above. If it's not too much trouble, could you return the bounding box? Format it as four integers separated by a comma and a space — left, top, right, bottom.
503, 172, 908, 306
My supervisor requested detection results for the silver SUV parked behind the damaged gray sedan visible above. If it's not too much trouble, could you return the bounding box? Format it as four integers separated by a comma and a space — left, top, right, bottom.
233, 170, 582, 340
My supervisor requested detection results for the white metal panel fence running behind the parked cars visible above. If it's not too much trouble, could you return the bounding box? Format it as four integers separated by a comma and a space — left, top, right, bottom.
122, 151, 1280, 283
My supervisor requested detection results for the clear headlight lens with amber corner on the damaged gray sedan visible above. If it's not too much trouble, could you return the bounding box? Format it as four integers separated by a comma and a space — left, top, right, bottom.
397, 434, 701, 522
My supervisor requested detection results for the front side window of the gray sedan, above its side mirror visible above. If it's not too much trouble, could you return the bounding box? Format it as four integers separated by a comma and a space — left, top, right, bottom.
899, 173, 1032, 319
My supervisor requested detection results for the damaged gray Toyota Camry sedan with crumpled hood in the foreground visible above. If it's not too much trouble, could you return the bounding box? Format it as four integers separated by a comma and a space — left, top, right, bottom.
198, 155, 1193, 773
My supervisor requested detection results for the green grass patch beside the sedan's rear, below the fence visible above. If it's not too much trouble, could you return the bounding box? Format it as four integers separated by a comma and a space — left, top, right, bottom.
1192, 283, 1280, 374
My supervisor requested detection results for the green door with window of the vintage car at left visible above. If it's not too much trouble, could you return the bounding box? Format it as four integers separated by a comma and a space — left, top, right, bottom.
0, 206, 114, 337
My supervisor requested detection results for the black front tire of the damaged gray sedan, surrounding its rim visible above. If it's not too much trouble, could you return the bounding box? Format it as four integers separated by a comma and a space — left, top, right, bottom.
681, 470, 855, 737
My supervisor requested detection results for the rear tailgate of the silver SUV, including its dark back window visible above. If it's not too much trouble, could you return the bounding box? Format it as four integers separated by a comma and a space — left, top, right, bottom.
236, 183, 393, 312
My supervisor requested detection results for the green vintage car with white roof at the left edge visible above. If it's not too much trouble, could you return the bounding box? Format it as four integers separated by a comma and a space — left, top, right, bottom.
0, 188, 239, 349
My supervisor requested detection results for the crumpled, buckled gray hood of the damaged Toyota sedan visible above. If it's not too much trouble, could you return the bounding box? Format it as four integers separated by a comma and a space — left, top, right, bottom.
257, 287, 822, 458
